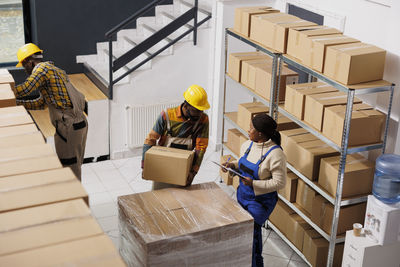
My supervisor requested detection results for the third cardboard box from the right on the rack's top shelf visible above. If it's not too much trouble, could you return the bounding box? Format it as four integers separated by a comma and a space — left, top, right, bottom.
286, 25, 342, 60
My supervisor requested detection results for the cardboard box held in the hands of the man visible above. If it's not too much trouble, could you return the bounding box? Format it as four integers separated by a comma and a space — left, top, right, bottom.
143, 146, 194, 186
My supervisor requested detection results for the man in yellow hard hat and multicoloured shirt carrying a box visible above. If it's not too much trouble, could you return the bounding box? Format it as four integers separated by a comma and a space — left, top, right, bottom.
142, 84, 210, 189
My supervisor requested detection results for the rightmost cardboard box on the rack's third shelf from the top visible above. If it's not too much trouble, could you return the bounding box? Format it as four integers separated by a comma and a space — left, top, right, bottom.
318, 154, 375, 198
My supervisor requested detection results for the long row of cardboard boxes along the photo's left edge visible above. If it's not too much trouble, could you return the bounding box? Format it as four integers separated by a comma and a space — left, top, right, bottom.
0, 70, 125, 266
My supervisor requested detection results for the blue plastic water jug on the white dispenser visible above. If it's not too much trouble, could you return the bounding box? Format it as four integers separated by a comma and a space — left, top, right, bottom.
372, 154, 400, 204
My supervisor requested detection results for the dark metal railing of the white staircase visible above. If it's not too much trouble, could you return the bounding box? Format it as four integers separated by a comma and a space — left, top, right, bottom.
105, 0, 211, 99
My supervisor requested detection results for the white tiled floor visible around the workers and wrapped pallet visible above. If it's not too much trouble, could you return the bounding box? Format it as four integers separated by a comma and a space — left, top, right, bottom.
82, 151, 308, 267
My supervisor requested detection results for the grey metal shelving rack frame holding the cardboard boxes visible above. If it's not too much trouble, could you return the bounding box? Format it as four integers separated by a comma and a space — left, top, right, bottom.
221, 29, 395, 266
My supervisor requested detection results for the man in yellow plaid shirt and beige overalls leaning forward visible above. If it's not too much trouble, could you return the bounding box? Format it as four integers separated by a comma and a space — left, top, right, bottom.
15, 43, 88, 180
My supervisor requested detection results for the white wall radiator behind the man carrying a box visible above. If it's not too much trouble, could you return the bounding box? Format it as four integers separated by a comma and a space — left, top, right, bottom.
126, 102, 181, 149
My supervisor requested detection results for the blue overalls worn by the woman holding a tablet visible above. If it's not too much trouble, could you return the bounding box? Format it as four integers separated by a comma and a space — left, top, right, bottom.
237, 142, 280, 267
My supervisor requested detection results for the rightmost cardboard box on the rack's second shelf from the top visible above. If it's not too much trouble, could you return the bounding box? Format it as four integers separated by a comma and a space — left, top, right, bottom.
322, 104, 386, 146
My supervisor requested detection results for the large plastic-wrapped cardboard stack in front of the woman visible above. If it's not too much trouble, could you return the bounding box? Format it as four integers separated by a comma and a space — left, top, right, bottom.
118, 183, 254, 266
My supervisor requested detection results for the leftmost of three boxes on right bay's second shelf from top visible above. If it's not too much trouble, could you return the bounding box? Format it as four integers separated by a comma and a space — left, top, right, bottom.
285, 82, 338, 120
